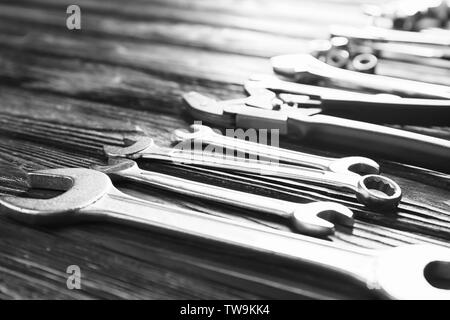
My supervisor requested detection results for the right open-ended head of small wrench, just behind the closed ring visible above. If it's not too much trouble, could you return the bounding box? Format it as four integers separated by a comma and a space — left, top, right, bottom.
328, 157, 380, 175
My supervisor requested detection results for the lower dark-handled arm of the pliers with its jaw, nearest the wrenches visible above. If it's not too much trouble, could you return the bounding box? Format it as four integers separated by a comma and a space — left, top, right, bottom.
183, 89, 450, 172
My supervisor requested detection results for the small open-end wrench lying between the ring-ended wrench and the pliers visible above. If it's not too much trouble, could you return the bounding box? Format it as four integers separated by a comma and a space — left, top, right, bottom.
172, 124, 380, 175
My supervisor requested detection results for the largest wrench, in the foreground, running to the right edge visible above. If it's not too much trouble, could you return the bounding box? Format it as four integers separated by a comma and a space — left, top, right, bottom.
0, 169, 450, 299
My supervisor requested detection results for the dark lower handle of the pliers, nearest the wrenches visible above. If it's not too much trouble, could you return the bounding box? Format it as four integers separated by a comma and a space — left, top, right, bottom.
288, 115, 450, 173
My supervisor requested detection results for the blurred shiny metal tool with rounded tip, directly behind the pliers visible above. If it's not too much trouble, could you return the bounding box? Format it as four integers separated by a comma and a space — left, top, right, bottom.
271, 54, 450, 99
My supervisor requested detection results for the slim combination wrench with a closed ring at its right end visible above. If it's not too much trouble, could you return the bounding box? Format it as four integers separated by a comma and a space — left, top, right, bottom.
104, 137, 402, 210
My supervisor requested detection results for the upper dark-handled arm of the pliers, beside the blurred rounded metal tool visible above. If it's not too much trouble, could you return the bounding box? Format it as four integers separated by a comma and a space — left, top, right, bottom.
241, 75, 450, 118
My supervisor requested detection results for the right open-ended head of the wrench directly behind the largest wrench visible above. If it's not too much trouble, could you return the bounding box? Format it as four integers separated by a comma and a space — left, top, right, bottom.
291, 201, 354, 237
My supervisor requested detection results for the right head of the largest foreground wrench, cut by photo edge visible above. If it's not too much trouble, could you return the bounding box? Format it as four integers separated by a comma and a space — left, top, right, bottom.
376, 245, 450, 300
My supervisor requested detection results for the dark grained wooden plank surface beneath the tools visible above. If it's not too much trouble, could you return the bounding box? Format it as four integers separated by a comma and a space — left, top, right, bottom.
0, 0, 450, 299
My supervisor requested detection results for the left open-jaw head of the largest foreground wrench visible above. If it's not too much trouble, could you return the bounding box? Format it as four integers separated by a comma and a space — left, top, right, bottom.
0, 168, 112, 224
